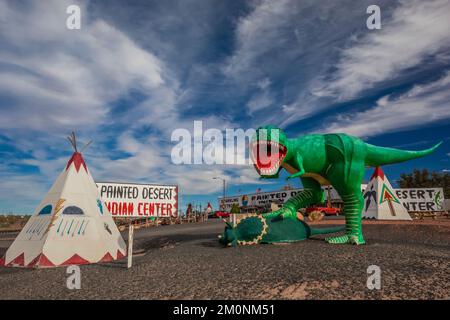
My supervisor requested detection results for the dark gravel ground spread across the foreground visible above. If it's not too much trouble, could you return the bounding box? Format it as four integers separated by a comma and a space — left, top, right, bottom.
0, 219, 450, 299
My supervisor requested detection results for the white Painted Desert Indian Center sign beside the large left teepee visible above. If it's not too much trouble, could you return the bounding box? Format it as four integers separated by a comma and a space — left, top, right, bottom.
97, 182, 178, 218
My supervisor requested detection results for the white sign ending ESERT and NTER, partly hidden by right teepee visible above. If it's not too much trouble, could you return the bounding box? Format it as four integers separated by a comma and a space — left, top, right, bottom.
395, 188, 445, 212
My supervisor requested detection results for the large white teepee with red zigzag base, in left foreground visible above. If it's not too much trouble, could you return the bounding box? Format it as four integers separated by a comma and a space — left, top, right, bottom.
3, 133, 126, 268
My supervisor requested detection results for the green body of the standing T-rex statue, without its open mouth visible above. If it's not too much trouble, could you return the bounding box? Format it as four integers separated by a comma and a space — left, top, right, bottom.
251, 126, 442, 244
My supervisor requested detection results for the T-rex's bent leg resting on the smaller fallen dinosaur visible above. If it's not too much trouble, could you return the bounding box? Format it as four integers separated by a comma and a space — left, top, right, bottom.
264, 178, 324, 219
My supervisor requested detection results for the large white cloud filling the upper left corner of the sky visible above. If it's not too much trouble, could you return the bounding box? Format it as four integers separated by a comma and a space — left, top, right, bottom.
0, 0, 166, 132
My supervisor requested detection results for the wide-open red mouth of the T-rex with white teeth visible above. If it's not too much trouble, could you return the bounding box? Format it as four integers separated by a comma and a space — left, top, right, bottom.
250, 140, 287, 176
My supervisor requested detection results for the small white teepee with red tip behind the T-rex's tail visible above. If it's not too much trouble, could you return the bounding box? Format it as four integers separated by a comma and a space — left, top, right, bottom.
362, 167, 412, 220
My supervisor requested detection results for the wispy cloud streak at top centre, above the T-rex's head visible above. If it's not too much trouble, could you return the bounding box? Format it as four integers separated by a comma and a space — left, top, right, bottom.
221, 0, 297, 115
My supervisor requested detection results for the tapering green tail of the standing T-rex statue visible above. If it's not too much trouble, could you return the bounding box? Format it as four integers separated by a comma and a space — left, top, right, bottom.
365, 141, 442, 167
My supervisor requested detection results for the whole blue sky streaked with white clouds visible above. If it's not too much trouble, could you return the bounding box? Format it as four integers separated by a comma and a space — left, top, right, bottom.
0, 0, 450, 212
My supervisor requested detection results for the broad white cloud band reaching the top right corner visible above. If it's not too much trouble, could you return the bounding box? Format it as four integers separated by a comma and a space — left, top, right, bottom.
314, 0, 450, 100
